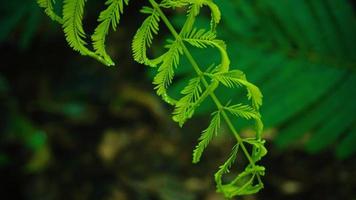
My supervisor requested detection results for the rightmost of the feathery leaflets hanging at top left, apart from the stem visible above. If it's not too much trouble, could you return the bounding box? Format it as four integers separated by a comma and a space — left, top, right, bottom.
91, 0, 129, 65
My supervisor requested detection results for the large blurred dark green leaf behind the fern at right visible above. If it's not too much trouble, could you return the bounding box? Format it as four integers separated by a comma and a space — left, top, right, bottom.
166, 0, 356, 158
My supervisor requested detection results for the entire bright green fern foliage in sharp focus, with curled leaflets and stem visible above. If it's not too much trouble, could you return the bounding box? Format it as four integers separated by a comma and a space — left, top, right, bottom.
38, 0, 267, 198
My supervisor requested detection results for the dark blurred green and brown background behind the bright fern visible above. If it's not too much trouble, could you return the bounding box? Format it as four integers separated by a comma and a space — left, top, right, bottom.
0, 0, 356, 200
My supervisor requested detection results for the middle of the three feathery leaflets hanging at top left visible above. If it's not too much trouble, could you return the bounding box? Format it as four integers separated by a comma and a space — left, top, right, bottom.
63, 0, 90, 55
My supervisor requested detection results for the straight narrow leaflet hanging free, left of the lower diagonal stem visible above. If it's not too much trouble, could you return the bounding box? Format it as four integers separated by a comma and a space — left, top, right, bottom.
193, 111, 221, 163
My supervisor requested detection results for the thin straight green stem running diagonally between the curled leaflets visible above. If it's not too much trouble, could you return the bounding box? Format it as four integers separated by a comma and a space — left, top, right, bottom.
149, 0, 263, 193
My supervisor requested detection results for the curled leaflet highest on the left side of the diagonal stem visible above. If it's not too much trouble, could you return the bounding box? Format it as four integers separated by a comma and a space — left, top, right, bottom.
132, 7, 161, 67
